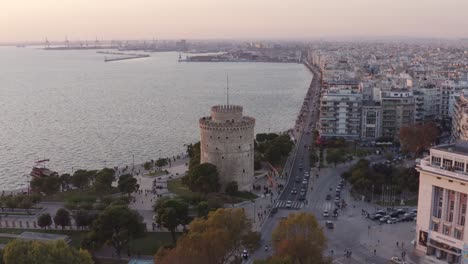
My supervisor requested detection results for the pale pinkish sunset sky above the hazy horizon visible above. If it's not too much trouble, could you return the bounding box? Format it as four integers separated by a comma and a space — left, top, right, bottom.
0, 0, 468, 42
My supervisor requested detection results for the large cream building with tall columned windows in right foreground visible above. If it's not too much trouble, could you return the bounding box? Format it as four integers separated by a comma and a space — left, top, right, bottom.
415, 141, 468, 263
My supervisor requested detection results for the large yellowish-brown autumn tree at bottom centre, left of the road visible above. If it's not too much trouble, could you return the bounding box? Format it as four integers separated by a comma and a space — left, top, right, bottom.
155, 208, 252, 264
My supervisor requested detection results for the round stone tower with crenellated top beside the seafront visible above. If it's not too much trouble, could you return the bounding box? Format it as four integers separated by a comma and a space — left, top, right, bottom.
199, 105, 255, 191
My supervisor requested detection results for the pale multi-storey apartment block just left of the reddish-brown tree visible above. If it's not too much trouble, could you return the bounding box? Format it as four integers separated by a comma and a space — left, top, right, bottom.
380, 89, 415, 138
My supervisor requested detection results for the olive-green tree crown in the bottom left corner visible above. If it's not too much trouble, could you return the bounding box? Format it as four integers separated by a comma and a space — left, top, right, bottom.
3, 239, 94, 264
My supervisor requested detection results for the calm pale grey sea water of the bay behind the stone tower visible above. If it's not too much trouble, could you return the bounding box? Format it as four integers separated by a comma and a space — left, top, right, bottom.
0, 47, 312, 189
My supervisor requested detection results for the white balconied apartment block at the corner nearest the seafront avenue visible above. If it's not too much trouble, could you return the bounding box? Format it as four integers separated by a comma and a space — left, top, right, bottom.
319, 88, 362, 139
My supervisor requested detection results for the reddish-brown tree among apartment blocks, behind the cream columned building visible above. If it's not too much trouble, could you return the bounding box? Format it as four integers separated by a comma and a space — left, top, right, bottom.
400, 122, 439, 155
